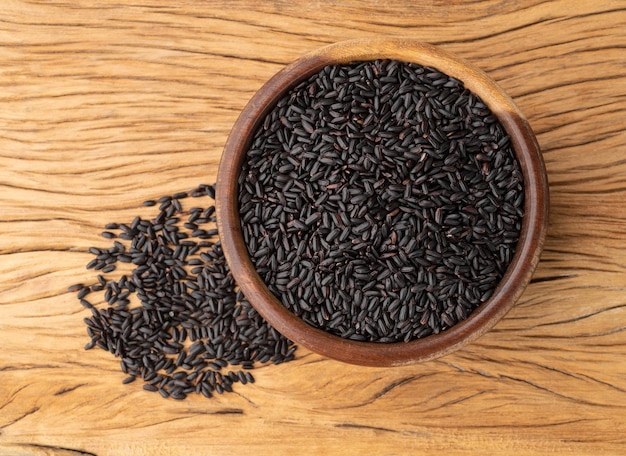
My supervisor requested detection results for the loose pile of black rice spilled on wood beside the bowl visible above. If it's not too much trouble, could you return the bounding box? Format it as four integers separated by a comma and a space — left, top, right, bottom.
68, 185, 296, 400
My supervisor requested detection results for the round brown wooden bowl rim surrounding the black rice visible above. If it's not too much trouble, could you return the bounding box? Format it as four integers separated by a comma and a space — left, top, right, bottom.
216, 39, 548, 366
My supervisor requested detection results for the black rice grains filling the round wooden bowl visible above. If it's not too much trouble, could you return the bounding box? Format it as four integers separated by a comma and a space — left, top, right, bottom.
238, 60, 524, 342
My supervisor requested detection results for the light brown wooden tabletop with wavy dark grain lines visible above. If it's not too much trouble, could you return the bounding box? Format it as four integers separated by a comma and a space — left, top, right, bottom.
0, 0, 626, 456
